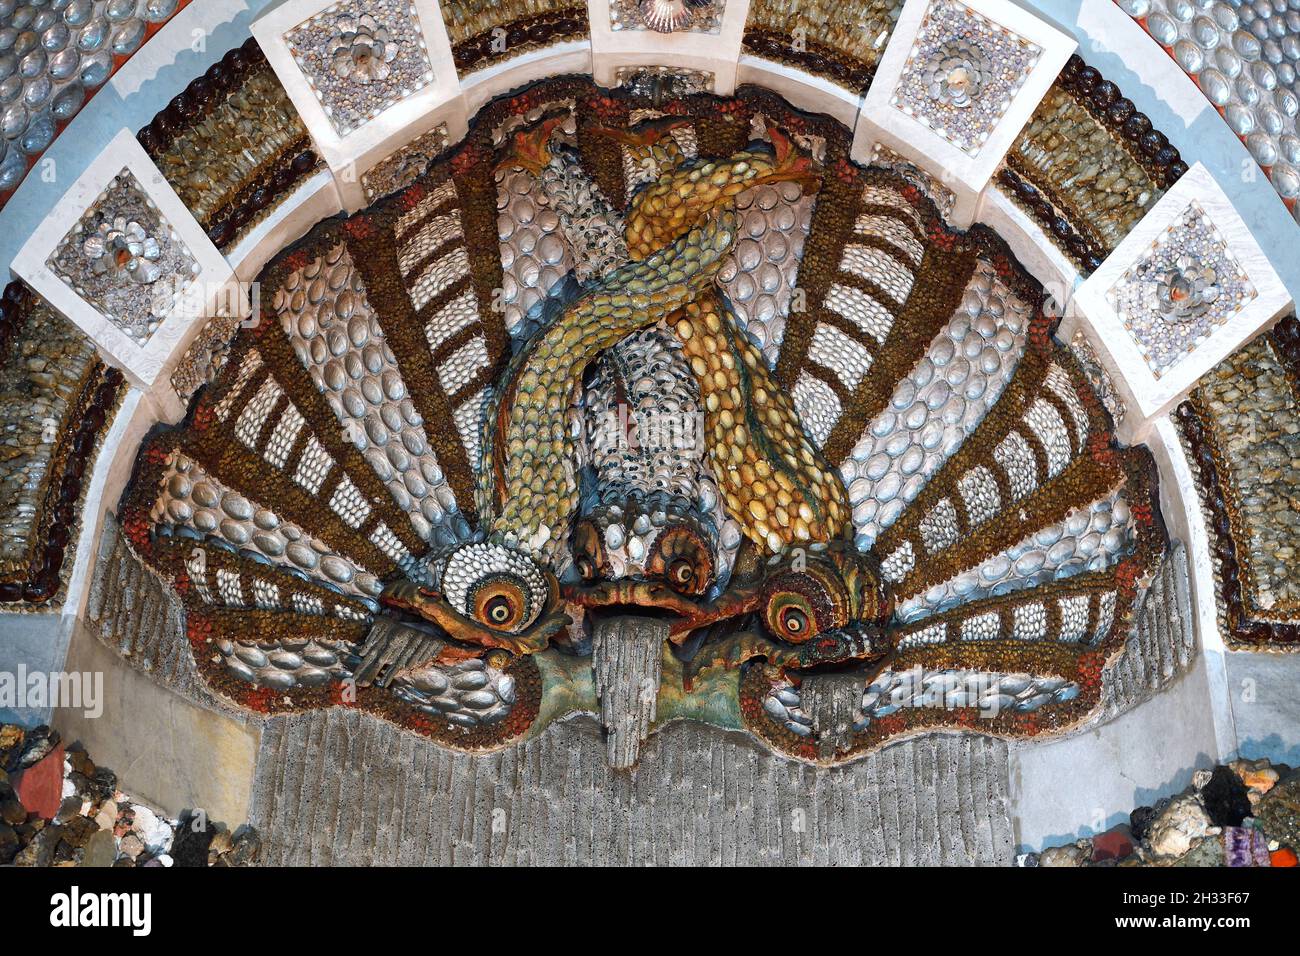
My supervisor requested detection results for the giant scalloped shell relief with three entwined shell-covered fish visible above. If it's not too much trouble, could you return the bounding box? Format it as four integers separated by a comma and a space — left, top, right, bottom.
121, 78, 1164, 766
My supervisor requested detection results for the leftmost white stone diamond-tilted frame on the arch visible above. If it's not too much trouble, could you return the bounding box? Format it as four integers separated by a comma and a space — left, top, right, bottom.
12, 129, 247, 416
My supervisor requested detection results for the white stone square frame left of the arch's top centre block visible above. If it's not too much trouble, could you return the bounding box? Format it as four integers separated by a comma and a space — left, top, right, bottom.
250, 0, 468, 211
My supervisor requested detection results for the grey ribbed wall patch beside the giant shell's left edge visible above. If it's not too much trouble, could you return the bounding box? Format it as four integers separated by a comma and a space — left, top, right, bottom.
86, 514, 192, 700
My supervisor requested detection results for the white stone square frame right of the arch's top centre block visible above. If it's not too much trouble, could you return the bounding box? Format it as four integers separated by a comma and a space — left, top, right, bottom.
852, 0, 1079, 229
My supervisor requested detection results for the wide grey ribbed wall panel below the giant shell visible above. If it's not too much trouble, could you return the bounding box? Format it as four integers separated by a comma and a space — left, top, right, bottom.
250, 708, 1013, 865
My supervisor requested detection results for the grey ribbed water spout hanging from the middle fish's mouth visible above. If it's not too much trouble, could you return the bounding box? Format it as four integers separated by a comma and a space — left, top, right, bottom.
592, 615, 668, 769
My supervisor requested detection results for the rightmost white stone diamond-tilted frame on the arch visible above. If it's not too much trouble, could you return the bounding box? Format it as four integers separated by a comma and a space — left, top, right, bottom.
1061, 163, 1292, 444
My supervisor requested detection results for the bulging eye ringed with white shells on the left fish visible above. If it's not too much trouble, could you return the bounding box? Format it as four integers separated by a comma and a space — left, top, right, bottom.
442, 542, 550, 633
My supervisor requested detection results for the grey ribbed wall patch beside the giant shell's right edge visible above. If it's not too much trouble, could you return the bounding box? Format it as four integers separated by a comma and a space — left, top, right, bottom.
1099, 544, 1196, 721
